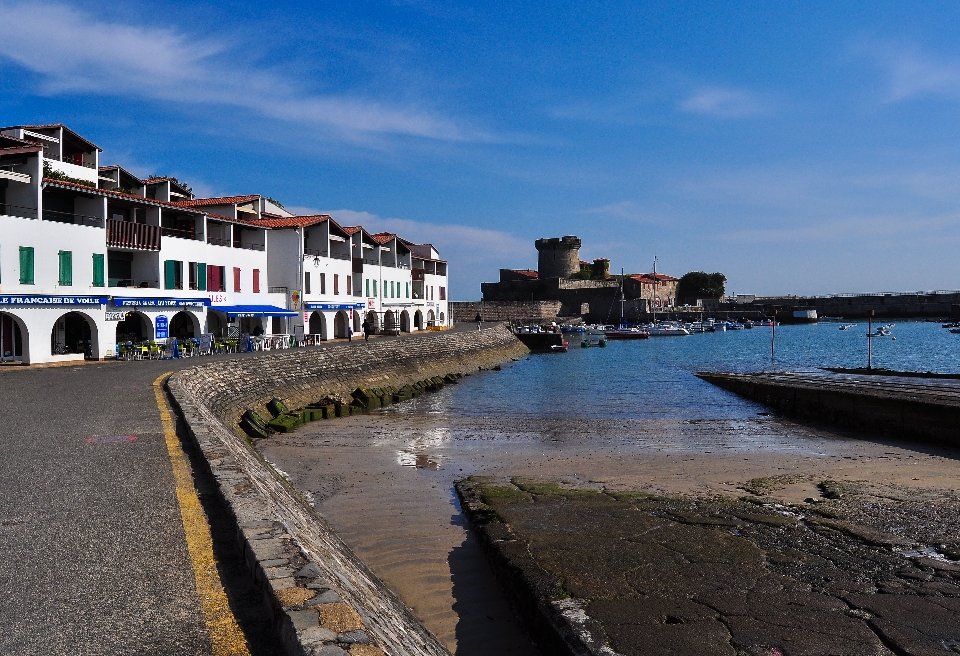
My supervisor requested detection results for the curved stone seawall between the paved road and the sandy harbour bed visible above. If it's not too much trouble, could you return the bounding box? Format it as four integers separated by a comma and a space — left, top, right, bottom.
167, 326, 528, 656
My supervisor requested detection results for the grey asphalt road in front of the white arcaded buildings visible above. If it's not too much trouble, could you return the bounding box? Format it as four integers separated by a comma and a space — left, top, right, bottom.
0, 336, 472, 656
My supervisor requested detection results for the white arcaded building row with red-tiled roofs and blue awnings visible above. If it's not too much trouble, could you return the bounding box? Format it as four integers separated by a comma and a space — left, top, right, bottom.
0, 125, 449, 363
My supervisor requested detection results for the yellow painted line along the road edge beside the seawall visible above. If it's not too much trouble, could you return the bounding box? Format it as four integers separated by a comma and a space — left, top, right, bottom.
153, 373, 250, 656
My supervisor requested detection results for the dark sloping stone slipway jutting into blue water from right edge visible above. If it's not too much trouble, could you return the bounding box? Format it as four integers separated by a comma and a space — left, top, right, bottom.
697, 372, 960, 446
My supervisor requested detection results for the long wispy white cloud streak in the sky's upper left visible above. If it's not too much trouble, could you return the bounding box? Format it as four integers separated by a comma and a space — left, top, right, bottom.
0, 0, 476, 141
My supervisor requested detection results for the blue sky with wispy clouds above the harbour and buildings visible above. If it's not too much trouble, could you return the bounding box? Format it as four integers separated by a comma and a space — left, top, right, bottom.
0, 0, 960, 300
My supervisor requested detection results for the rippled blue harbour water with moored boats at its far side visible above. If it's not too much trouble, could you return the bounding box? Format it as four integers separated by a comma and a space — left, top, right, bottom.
388, 321, 960, 420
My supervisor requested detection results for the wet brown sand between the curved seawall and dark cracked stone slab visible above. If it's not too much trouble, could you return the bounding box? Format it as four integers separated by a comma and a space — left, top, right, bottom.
258, 412, 960, 656
